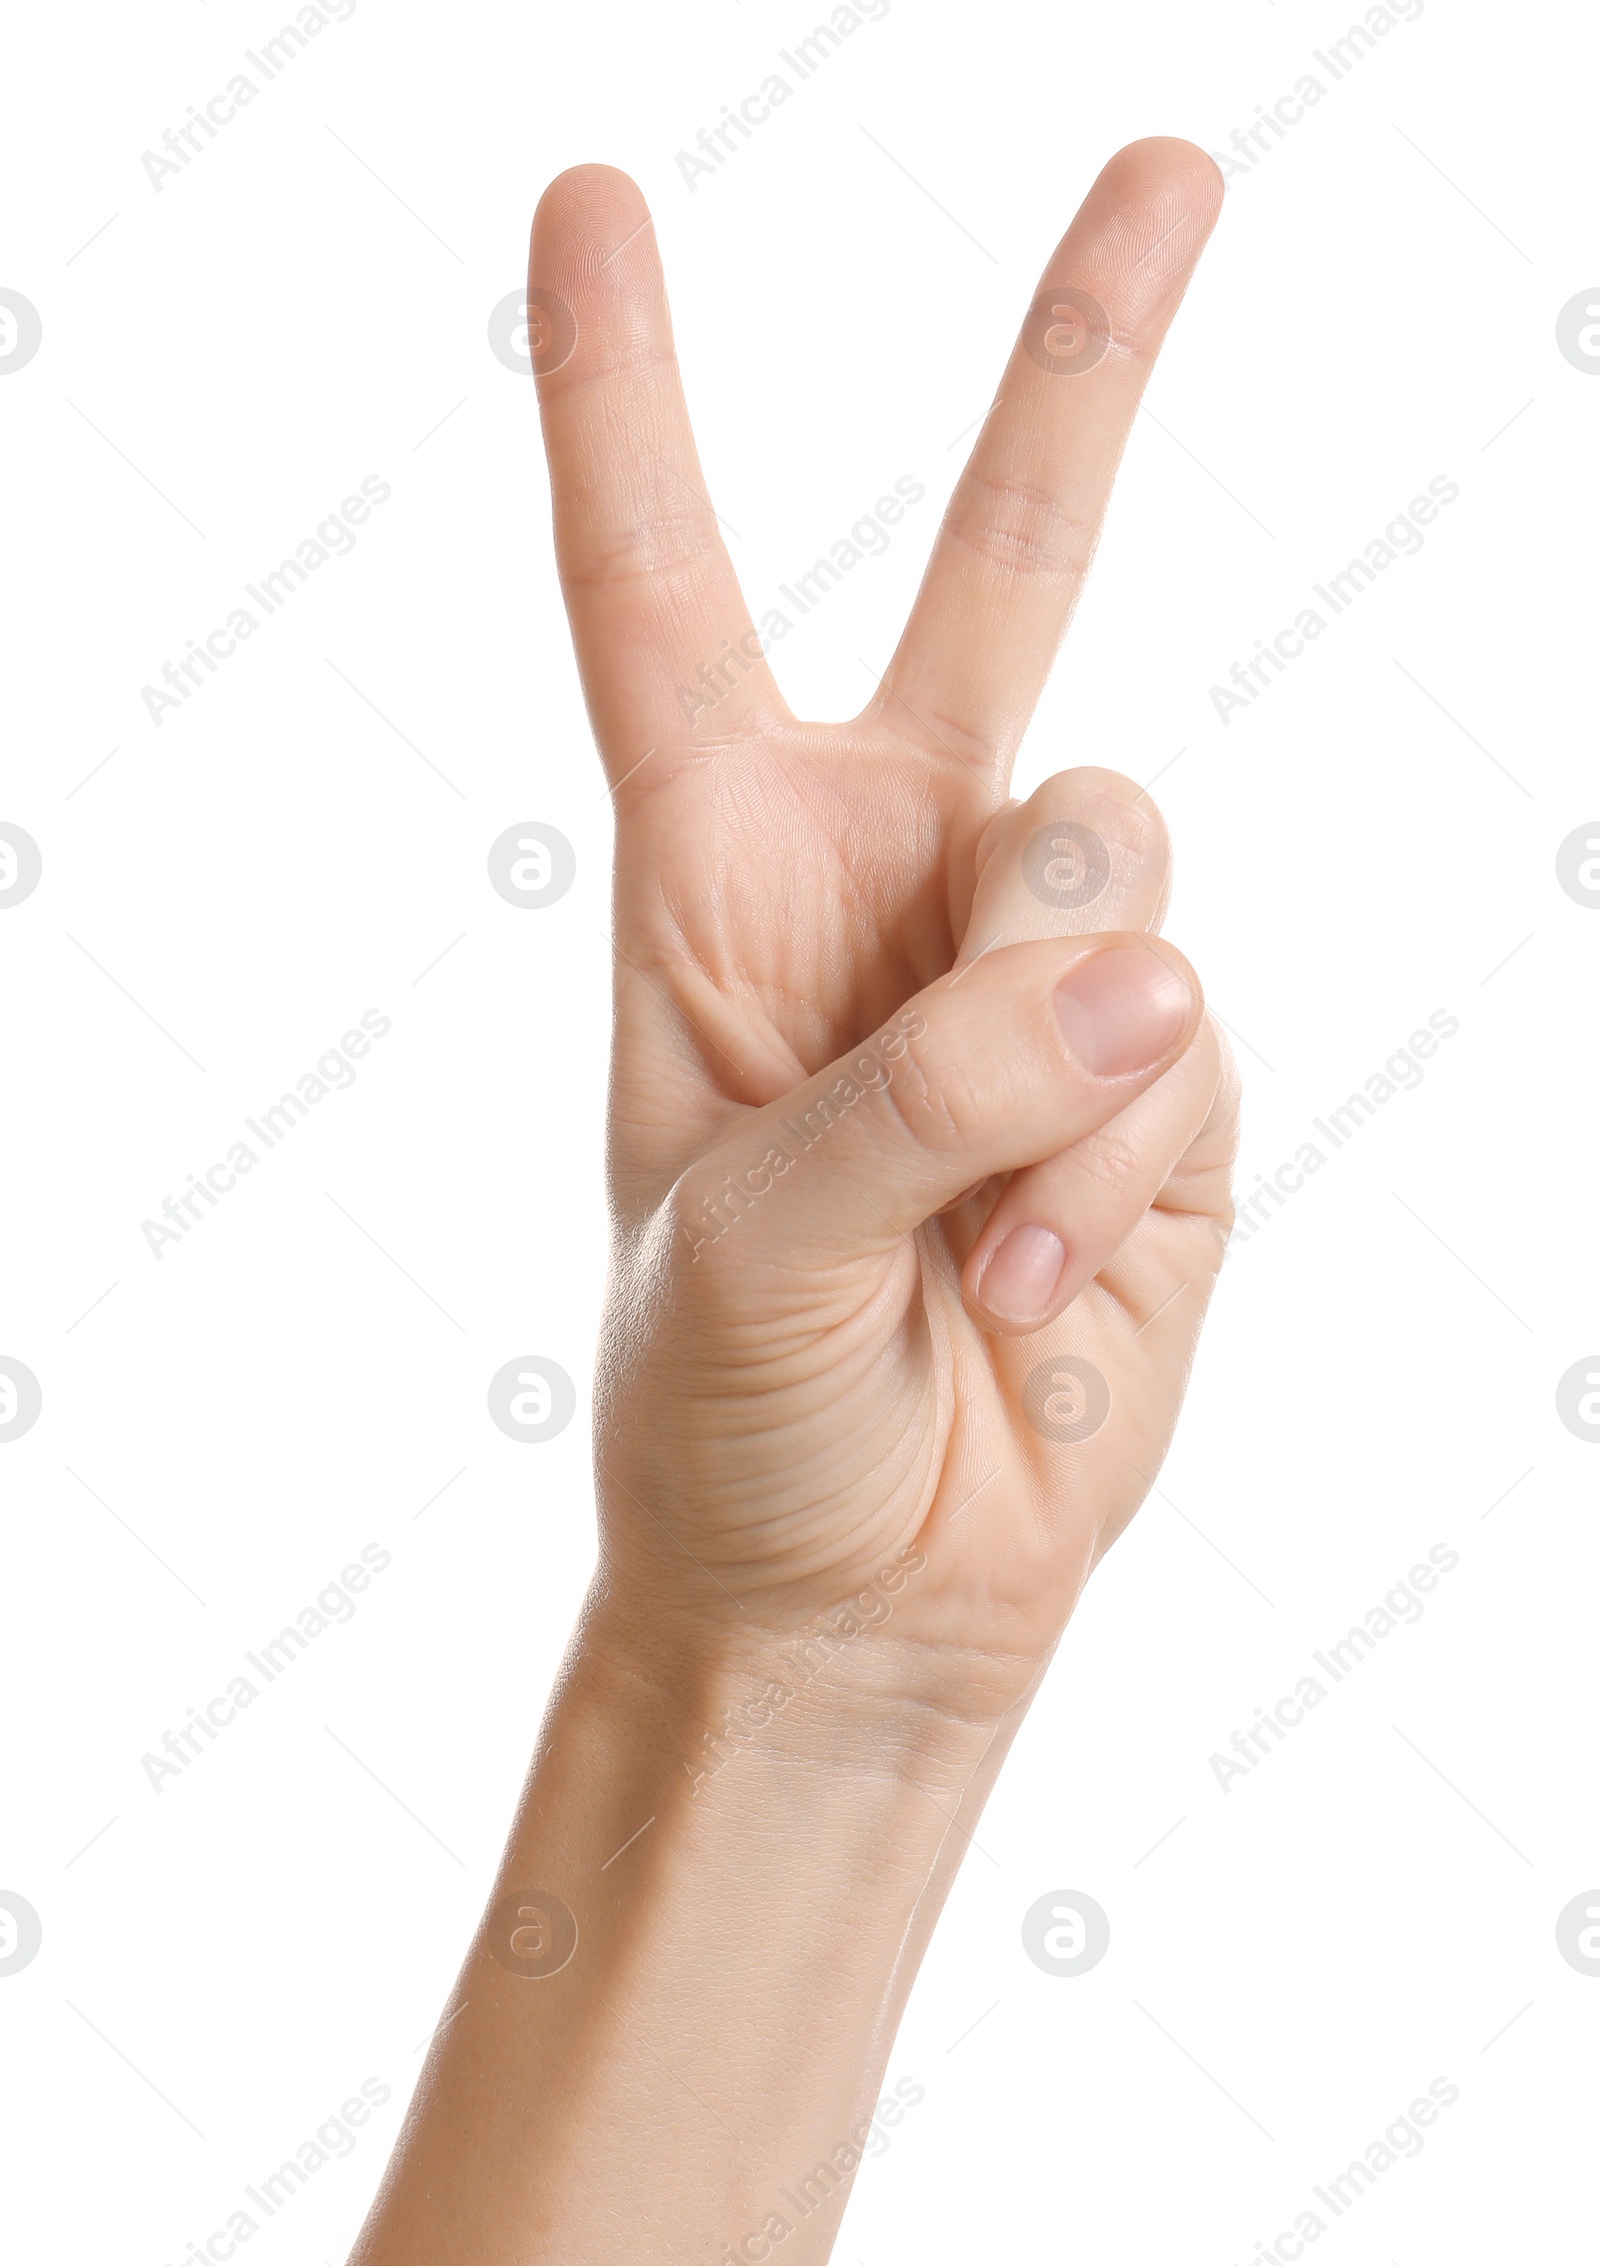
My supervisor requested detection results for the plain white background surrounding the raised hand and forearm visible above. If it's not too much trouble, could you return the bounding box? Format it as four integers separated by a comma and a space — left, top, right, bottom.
0, 0, 1600, 2266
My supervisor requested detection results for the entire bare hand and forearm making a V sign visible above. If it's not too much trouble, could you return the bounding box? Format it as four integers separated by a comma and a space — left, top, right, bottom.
351, 140, 1235, 2266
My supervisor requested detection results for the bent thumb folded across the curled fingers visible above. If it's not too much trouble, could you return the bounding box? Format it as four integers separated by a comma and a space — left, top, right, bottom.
673, 934, 1201, 1267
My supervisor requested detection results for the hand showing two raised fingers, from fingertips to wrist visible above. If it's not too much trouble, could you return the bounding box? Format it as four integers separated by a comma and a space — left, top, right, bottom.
530, 140, 1235, 1715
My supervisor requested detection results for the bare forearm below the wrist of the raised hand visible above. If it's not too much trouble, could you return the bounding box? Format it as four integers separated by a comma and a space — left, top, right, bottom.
351, 1604, 1024, 2266
